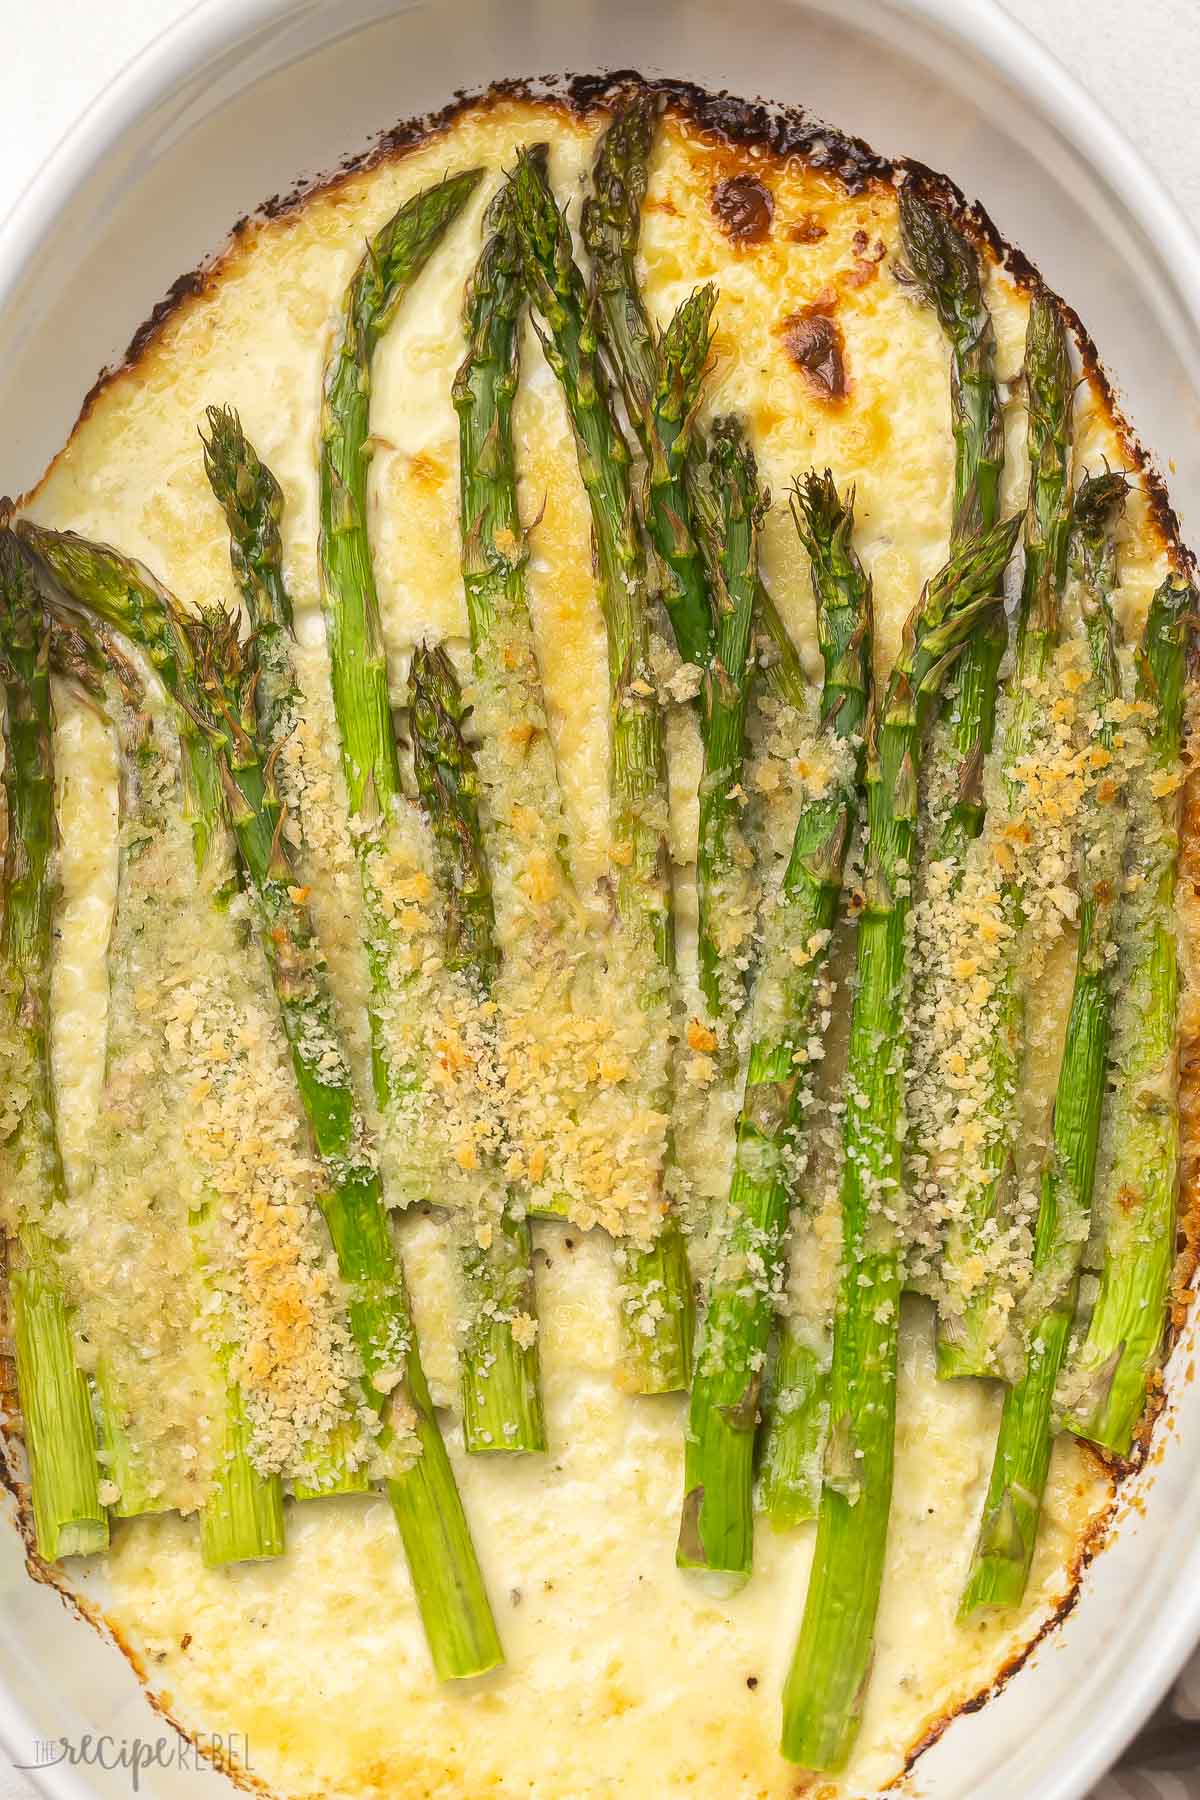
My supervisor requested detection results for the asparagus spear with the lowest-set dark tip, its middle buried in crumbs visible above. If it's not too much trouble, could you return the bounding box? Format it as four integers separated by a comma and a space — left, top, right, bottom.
408, 646, 545, 1451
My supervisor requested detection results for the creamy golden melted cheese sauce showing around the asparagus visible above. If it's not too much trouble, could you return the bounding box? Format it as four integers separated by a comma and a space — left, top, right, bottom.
18, 101, 1162, 1800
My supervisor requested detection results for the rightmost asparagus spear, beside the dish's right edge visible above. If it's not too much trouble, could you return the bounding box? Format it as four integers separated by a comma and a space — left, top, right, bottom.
1063, 574, 1196, 1456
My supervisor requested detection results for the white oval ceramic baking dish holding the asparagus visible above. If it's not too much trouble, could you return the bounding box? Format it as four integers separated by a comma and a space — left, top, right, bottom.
0, 0, 1200, 1800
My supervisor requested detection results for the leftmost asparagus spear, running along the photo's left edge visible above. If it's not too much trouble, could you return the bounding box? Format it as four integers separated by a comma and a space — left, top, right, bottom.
0, 520, 108, 1562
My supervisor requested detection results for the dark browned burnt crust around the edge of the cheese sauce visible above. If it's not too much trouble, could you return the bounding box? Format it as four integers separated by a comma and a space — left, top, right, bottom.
9, 68, 1200, 1796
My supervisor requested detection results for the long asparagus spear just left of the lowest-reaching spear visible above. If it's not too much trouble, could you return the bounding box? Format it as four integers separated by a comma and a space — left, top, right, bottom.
676, 472, 871, 1577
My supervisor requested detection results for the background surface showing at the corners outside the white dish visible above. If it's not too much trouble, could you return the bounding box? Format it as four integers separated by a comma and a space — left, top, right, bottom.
0, 0, 1200, 1800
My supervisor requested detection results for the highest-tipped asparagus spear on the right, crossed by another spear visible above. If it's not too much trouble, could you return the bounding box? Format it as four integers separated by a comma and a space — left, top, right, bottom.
900, 178, 1006, 860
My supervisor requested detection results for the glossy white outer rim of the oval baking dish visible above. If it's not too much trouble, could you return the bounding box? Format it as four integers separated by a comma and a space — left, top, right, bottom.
0, 0, 1200, 1800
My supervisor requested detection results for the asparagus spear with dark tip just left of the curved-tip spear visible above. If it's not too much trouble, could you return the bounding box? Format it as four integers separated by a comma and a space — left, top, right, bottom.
200, 407, 371, 1499
